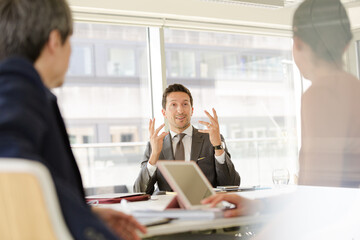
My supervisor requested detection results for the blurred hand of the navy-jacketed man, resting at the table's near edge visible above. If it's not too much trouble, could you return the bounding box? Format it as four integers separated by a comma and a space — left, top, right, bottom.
92, 207, 146, 240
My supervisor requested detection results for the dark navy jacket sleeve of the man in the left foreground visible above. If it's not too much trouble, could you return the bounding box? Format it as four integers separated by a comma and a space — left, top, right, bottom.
0, 78, 117, 240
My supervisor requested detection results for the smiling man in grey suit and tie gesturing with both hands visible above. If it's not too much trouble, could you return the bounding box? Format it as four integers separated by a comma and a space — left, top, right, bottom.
134, 84, 240, 194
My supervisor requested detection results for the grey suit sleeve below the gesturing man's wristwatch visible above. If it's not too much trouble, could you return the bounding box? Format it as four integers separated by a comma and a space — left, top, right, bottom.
214, 135, 241, 186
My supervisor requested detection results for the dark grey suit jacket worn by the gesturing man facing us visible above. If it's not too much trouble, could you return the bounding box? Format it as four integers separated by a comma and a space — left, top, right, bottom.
134, 128, 240, 194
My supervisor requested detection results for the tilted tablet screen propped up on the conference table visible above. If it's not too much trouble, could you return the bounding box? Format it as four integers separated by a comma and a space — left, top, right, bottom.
165, 162, 213, 205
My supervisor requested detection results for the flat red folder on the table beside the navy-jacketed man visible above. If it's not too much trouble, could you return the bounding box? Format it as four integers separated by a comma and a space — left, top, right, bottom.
86, 193, 151, 204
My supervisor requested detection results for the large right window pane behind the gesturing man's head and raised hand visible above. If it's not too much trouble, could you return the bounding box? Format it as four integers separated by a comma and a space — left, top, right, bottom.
164, 29, 298, 185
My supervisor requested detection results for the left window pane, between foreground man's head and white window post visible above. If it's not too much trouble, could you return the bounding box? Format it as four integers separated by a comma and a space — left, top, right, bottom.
55, 23, 151, 190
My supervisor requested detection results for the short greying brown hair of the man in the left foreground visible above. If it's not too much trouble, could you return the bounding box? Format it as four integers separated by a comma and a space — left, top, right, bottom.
0, 0, 73, 62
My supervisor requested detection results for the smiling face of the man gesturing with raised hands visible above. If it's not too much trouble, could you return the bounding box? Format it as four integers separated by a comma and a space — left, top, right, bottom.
162, 92, 194, 133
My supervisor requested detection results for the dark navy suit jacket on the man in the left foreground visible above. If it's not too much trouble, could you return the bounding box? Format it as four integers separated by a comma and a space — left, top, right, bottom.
0, 58, 117, 239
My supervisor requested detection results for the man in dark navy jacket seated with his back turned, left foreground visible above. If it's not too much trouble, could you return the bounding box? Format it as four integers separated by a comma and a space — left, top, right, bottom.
0, 0, 145, 240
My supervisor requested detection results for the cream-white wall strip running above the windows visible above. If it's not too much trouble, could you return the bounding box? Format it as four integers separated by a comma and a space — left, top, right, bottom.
68, 0, 360, 76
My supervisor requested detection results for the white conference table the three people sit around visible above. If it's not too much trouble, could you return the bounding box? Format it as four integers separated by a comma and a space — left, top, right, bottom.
103, 186, 360, 240
